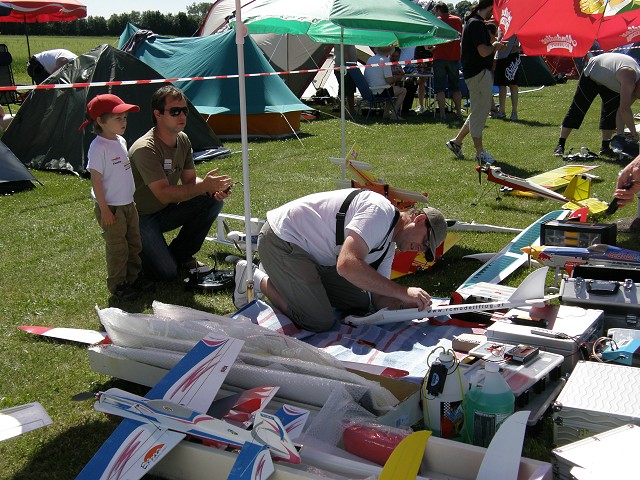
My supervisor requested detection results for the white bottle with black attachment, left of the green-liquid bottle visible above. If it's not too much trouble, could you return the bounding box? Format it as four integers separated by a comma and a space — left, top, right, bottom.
421, 349, 469, 440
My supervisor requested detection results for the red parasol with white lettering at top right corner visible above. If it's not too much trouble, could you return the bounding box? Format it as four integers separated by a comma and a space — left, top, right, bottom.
493, 0, 640, 57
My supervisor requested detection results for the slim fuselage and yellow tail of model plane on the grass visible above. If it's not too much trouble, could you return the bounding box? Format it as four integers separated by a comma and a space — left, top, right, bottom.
476, 165, 609, 214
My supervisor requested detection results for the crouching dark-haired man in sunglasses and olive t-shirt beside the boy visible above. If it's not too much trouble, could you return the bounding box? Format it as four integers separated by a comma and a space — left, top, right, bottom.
129, 85, 232, 280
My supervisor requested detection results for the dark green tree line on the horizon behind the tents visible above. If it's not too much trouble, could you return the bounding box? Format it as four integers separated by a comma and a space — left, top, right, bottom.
0, 0, 472, 37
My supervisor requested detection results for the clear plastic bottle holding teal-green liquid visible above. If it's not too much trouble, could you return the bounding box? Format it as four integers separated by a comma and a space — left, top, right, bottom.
464, 362, 515, 447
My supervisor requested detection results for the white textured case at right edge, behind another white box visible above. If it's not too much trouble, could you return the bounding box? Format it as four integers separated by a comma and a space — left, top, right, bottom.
553, 362, 640, 446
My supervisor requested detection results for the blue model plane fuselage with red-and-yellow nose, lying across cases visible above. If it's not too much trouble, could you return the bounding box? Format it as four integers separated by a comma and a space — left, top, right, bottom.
521, 244, 640, 268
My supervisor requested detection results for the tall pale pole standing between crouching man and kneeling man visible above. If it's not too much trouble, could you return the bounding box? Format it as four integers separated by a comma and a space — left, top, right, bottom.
235, 0, 254, 301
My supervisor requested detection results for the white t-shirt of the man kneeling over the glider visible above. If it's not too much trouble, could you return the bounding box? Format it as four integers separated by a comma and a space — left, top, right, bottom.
267, 189, 396, 277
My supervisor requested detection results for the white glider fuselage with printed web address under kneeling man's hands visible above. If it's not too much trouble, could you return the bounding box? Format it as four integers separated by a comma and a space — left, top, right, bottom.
343, 268, 548, 326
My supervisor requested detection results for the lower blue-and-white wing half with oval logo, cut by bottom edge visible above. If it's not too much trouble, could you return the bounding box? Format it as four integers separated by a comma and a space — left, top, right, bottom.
76, 418, 185, 480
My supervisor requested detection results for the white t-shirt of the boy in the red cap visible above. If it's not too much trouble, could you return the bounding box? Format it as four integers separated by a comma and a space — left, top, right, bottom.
87, 135, 135, 206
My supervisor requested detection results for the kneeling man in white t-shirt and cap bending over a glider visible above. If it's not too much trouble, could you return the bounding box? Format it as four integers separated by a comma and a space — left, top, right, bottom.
233, 189, 447, 332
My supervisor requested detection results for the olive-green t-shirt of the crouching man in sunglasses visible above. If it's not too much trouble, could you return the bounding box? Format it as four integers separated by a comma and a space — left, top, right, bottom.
129, 128, 195, 215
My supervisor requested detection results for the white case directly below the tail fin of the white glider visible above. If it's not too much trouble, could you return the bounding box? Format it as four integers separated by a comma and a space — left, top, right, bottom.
485, 305, 604, 375
